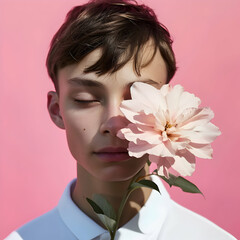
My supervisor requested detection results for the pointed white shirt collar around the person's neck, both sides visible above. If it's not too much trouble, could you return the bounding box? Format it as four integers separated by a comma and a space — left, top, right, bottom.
57, 176, 170, 240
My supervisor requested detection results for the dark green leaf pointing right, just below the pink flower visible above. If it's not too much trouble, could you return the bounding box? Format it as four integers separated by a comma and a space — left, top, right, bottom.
159, 174, 203, 195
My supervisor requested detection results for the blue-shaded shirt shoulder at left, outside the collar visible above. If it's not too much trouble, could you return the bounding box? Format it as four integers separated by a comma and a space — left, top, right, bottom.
5, 208, 75, 240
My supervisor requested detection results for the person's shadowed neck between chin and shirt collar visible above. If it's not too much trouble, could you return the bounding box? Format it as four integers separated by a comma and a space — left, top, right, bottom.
72, 164, 151, 227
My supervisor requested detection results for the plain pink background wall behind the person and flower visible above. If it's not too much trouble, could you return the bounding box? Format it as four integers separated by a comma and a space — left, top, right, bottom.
0, 0, 240, 239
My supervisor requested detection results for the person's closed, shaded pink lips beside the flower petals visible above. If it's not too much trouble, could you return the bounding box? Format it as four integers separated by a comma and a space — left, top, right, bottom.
94, 147, 130, 162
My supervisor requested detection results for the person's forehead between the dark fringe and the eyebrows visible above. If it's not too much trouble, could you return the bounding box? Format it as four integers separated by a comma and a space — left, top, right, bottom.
58, 44, 167, 88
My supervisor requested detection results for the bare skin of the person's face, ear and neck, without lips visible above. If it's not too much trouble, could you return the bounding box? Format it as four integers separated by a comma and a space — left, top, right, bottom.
48, 43, 167, 226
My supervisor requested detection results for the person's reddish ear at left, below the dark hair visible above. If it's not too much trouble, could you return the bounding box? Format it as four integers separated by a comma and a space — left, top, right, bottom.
47, 91, 65, 129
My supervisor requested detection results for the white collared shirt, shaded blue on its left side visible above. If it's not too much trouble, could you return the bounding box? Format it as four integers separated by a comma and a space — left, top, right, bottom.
5, 176, 236, 240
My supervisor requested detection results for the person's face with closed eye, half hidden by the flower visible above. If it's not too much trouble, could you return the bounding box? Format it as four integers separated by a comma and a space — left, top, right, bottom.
48, 43, 167, 181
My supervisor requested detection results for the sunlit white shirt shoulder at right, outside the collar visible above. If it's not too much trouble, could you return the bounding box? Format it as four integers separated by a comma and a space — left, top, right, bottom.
158, 200, 236, 240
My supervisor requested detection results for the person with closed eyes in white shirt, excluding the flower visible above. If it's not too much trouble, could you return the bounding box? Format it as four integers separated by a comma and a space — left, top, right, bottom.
6, 0, 235, 240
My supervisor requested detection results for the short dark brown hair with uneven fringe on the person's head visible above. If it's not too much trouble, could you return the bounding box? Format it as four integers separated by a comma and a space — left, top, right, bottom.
46, 0, 176, 90
